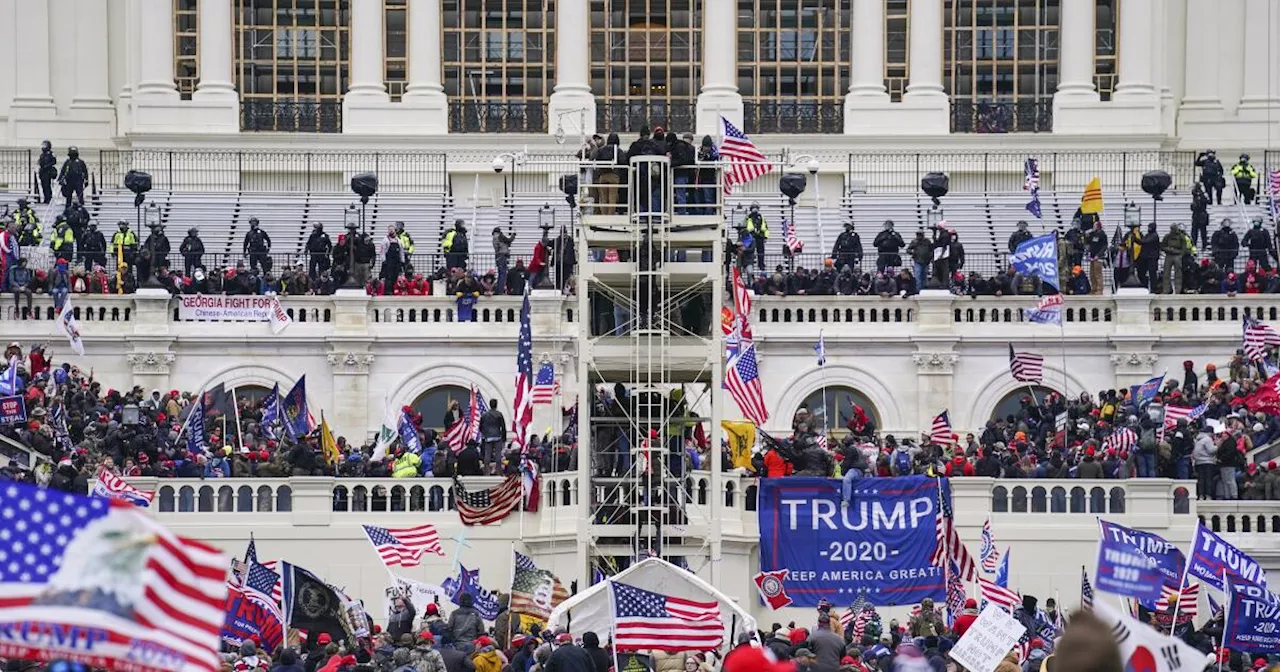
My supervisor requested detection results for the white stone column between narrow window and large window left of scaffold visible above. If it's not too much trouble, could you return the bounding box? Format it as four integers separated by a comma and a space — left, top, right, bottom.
401, 0, 449, 133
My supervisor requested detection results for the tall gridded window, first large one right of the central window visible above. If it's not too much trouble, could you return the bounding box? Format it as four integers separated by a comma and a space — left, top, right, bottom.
737, 0, 850, 133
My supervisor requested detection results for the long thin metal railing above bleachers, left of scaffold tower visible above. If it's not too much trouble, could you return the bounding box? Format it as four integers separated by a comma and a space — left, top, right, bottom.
97, 150, 449, 193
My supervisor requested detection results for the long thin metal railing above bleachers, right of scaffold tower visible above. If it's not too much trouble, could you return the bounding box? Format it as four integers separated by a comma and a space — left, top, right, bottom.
849, 151, 1208, 193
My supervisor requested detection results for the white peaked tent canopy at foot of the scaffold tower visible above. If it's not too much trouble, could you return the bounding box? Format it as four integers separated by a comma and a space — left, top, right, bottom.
547, 558, 756, 646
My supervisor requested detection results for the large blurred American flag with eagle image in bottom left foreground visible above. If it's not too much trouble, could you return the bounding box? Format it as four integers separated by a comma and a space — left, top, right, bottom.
0, 483, 228, 672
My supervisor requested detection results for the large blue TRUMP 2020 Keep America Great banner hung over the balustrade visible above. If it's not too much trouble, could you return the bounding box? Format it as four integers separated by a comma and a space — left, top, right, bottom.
759, 476, 946, 607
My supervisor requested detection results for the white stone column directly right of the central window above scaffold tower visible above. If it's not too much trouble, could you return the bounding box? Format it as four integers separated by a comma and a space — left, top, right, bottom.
696, 0, 745, 137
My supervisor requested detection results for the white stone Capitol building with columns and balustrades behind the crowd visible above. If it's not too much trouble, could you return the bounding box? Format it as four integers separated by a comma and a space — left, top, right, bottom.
0, 0, 1280, 626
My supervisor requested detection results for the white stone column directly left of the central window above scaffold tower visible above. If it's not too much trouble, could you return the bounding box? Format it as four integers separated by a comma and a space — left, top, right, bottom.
547, 0, 595, 136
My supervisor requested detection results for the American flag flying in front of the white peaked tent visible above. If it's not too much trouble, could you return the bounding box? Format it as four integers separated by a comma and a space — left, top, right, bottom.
609, 581, 724, 653
